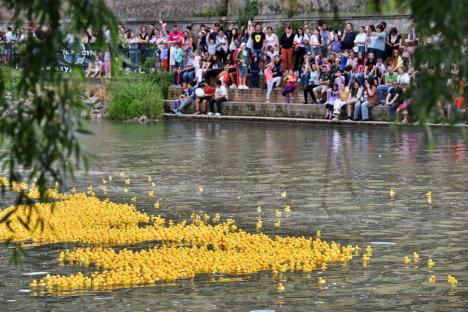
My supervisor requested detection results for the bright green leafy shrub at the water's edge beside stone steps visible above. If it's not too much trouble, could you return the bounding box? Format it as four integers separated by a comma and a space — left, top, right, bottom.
109, 80, 164, 120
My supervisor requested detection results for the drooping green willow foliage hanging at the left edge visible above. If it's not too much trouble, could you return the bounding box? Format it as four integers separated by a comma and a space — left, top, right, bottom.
0, 0, 117, 229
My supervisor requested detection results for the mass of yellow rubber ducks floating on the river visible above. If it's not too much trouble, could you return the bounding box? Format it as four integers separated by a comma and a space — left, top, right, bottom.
0, 178, 458, 293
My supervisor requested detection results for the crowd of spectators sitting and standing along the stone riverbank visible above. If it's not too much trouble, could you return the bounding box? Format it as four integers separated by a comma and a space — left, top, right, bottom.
0, 20, 464, 122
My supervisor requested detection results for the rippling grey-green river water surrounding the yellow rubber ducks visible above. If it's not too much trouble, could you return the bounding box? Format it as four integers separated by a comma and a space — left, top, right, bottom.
0, 121, 468, 311
